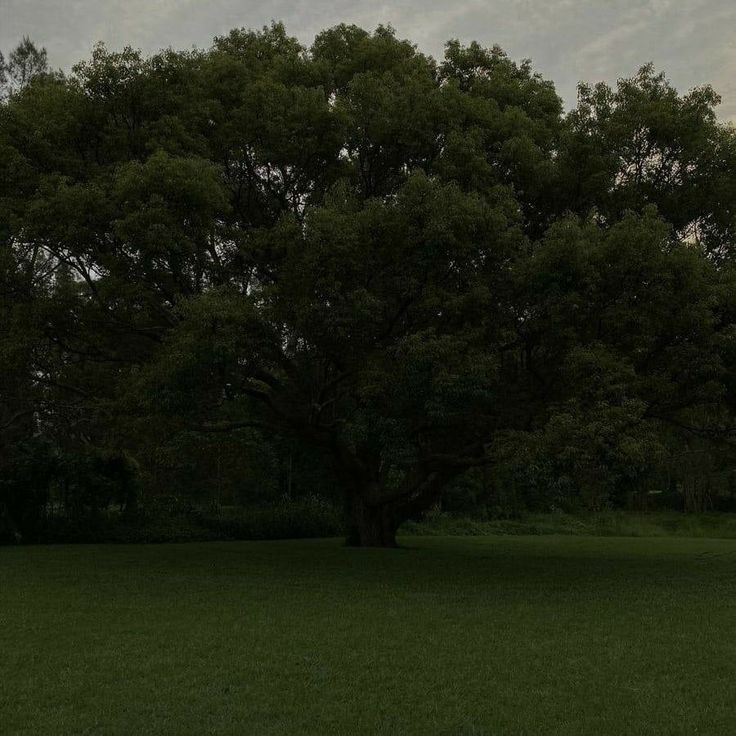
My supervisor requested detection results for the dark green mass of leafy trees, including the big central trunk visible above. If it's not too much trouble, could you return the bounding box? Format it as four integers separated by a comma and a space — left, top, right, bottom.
0, 23, 736, 546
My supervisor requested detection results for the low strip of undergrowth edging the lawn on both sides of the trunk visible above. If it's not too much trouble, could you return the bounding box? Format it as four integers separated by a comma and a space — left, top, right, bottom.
14, 497, 736, 544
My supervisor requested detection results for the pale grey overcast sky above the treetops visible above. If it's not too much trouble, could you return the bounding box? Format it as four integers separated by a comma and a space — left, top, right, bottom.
0, 0, 736, 121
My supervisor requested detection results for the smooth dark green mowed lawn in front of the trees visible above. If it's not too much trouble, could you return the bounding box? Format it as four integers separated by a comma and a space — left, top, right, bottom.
0, 536, 736, 736
